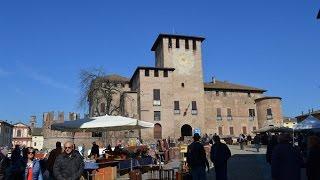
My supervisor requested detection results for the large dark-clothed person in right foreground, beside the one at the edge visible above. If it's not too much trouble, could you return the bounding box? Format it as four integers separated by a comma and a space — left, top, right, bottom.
271, 134, 303, 180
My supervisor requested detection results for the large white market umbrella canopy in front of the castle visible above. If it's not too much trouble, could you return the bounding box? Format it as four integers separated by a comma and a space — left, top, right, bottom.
51, 115, 154, 132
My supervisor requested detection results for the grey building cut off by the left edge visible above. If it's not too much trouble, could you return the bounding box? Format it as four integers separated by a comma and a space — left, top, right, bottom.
0, 120, 13, 148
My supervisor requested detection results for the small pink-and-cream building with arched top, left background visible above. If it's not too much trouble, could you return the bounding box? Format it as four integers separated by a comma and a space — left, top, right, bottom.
12, 122, 32, 147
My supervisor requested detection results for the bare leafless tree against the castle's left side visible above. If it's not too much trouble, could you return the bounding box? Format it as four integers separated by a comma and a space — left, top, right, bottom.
79, 68, 123, 116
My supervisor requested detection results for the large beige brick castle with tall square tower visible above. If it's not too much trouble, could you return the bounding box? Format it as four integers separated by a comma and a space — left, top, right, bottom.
89, 34, 282, 139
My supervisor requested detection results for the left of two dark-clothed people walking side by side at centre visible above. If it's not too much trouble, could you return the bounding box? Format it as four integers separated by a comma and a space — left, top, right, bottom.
187, 133, 209, 180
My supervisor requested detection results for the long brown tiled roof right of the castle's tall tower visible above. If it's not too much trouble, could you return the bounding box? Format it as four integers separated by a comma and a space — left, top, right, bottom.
204, 80, 266, 93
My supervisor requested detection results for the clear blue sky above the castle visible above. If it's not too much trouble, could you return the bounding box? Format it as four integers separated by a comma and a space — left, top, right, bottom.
0, 0, 320, 125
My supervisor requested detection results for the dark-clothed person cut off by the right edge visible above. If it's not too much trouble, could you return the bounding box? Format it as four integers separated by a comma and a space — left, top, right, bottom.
306, 136, 320, 180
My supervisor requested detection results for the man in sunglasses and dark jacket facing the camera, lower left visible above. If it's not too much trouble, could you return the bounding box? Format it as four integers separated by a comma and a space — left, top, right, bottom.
53, 142, 84, 180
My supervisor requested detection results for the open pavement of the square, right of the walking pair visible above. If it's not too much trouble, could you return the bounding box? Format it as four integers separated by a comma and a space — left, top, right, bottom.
207, 146, 306, 180
